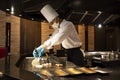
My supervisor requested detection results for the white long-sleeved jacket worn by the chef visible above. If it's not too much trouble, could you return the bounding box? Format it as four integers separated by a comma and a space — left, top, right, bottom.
44, 19, 81, 49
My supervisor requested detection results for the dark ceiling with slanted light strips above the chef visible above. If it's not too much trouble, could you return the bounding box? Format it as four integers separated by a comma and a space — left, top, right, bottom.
0, 0, 120, 25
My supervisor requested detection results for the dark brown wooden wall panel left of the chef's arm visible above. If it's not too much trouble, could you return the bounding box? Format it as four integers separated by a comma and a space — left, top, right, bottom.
20, 19, 41, 53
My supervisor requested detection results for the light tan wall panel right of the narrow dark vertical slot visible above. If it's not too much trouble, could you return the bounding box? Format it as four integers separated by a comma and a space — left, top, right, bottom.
7, 16, 20, 54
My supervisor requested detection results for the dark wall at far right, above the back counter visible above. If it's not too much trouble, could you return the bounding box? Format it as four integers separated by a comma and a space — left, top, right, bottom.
95, 26, 120, 51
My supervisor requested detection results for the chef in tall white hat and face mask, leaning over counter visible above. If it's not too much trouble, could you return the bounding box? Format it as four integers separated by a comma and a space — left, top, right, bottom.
33, 4, 84, 66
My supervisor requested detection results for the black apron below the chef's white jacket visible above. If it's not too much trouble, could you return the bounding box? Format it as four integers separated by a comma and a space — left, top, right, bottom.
65, 47, 84, 66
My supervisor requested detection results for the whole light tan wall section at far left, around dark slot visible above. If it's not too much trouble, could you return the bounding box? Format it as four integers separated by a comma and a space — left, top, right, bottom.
0, 10, 20, 54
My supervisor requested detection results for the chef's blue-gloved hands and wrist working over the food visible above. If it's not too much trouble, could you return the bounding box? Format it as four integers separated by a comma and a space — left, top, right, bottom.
33, 44, 47, 58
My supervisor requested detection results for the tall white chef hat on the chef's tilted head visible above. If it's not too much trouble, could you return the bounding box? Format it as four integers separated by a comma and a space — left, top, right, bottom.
40, 4, 58, 23
